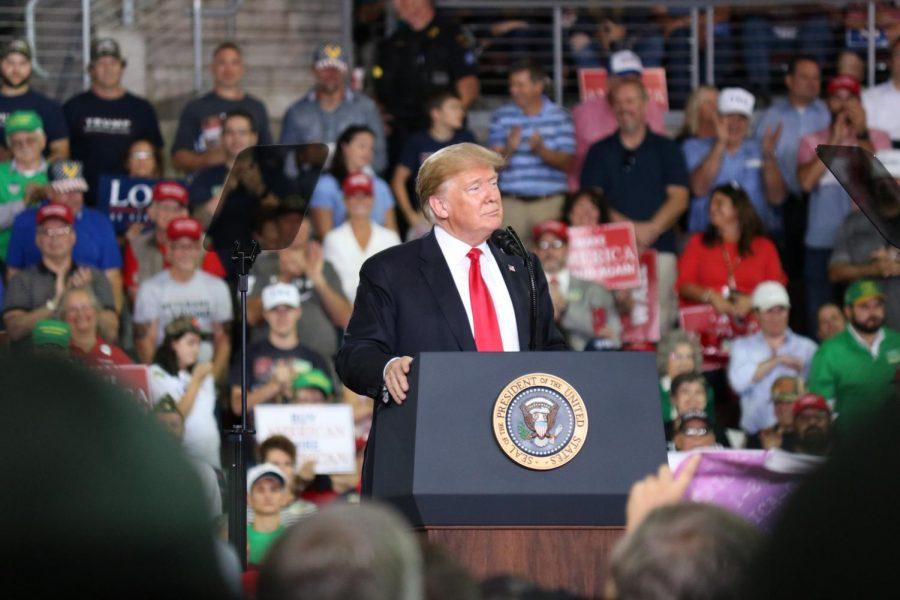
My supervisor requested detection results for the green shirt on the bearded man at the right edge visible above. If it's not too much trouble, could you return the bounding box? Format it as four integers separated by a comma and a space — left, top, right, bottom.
809, 325, 900, 431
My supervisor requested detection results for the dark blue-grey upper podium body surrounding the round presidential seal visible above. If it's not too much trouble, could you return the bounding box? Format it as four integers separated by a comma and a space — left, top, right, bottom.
373, 352, 666, 526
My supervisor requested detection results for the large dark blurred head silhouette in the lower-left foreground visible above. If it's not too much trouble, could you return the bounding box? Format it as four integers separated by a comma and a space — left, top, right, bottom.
0, 353, 231, 599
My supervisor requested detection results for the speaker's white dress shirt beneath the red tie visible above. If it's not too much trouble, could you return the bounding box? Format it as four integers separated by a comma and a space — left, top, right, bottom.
434, 226, 520, 352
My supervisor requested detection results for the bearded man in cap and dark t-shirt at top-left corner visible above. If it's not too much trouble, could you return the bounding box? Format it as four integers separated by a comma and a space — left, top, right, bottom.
0, 40, 69, 160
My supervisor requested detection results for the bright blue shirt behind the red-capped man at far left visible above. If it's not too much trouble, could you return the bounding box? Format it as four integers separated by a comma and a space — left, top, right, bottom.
6, 207, 122, 271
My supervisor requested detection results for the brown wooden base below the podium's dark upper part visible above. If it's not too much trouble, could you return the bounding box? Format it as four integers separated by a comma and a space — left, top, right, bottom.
420, 526, 625, 598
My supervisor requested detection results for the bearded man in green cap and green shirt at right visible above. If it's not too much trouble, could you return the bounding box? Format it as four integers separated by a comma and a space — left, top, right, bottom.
809, 279, 900, 431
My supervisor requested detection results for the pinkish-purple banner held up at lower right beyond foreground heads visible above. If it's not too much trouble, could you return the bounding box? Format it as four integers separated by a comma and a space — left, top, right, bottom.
669, 450, 822, 531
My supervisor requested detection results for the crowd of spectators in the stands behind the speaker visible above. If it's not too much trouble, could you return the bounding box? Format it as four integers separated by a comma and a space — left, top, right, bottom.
0, 0, 900, 585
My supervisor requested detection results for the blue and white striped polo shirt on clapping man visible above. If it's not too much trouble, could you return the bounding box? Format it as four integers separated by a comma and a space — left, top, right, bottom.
488, 97, 575, 196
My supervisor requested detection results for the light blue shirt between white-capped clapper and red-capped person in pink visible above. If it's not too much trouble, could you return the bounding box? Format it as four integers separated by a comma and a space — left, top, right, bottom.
753, 98, 831, 194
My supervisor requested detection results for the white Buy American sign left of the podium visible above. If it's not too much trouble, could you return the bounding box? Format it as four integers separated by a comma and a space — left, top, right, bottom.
253, 404, 356, 475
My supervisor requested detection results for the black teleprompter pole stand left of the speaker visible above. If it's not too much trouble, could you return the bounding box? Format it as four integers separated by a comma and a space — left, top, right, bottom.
227, 240, 259, 570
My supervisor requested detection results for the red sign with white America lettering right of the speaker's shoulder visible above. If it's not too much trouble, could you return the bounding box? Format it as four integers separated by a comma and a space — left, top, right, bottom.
567, 223, 641, 290
